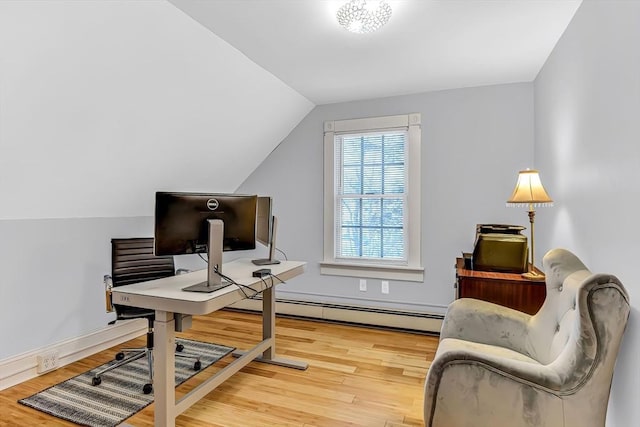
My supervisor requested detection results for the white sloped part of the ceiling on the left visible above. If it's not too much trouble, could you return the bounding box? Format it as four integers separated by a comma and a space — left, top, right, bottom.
0, 0, 313, 219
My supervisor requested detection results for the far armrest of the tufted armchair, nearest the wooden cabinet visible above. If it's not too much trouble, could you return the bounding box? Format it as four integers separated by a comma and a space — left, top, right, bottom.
440, 298, 532, 356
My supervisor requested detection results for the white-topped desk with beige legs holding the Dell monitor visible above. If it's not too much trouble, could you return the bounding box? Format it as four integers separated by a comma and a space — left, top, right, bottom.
112, 260, 307, 427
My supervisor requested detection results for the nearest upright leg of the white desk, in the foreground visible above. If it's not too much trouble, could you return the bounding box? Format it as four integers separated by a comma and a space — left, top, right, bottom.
153, 311, 176, 427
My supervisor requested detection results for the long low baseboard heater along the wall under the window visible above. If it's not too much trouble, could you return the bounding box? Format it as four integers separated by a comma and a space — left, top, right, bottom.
230, 298, 444, 335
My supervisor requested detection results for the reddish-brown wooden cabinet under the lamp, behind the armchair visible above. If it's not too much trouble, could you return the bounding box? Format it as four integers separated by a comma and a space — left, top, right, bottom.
456, 258, 547, 314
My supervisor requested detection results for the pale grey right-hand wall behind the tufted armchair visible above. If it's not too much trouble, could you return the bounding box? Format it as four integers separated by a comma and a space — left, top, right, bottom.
535, 1, 640, 427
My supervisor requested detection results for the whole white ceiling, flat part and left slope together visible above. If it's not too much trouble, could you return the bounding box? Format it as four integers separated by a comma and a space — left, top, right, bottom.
0, 0, 580, 220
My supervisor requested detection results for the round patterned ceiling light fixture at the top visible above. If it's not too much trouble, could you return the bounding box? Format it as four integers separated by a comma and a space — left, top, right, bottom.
336, 0, 391, 33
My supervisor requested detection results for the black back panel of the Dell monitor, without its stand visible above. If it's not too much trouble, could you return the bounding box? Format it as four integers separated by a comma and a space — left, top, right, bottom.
155, 192, 257, 255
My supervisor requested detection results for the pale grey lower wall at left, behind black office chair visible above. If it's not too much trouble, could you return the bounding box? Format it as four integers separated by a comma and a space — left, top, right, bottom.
0, 217, 153, 359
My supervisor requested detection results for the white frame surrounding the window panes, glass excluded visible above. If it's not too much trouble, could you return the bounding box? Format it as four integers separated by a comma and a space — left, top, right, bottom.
320, 113, 424, 282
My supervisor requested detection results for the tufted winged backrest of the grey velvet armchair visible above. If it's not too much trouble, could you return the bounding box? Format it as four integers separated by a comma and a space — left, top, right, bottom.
529, 249, 630, 392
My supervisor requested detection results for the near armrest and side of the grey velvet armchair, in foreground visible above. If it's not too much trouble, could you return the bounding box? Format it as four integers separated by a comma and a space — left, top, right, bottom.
424, 338, 564, 427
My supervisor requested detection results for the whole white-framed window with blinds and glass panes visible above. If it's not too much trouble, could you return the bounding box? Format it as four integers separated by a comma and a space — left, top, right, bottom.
321, 114, 423, 281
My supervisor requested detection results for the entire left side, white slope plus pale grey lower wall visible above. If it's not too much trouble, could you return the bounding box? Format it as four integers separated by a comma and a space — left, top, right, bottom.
0, 0, 312, 359
